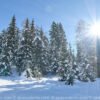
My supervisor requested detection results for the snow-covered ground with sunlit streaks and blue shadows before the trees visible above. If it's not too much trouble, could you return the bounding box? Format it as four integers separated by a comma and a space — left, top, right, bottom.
0, 76, 100, 100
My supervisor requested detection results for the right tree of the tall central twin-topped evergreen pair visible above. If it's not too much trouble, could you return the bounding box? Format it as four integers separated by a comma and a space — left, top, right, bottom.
57, 23, 69, 80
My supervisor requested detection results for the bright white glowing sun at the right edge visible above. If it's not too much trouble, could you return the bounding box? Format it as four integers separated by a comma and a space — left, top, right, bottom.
90, 22, 100, 37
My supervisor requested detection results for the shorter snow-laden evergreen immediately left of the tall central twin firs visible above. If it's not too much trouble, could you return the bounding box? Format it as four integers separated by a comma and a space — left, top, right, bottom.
33, 29, 49, 74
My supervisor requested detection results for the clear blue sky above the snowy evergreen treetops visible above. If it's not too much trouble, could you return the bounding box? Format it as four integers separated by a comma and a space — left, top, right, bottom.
0, 0, 100, 48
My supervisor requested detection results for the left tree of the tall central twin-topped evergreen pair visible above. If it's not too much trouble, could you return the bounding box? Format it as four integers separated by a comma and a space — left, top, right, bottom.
50, 22, 61, 74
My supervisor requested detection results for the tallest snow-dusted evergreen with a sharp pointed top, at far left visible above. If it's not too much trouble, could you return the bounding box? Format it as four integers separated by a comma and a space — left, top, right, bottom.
1, 16, 19, 74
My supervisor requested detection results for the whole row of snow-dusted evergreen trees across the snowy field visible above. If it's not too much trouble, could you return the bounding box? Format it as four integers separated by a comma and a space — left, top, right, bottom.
0, 16, 97, 85
